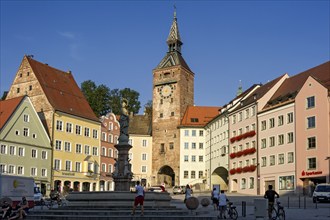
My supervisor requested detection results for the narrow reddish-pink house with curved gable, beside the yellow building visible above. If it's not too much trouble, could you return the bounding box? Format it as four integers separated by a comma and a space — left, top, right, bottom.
100, 113, 120, 191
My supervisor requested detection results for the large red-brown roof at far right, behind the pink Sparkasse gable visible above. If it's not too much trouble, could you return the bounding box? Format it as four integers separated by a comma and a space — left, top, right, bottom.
263, 61, 330, 110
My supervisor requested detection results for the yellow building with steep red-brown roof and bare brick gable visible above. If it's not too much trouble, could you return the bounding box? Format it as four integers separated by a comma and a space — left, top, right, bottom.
7, 56, 101, 192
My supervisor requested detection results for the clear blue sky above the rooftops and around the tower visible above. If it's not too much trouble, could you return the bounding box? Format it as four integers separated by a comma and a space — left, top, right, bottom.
0, 0, 330, 113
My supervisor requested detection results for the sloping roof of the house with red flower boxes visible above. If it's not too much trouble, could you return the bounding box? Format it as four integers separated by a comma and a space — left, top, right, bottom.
235, 74, 285, 110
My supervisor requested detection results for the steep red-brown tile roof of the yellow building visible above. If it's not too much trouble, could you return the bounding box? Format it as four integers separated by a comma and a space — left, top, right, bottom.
27, 57, 99, 122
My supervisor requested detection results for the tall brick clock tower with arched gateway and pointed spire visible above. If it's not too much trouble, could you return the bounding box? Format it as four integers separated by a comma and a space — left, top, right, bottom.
152, 9, 194, 186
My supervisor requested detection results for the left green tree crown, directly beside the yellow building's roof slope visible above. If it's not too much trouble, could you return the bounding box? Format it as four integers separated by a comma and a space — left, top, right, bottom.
81, 80, 110, 117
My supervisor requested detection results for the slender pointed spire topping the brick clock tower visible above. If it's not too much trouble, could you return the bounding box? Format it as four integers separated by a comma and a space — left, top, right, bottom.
166, 5, 183, 53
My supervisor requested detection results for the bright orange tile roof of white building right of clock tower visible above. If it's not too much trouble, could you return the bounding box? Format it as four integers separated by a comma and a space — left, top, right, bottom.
179, 106, 221, 127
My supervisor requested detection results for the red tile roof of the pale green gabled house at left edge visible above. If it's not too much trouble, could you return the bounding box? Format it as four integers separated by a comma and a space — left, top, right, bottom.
0, 96, 25, 129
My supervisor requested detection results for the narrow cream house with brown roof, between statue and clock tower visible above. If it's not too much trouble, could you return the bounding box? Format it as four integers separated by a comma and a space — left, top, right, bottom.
128, 112, 156, 187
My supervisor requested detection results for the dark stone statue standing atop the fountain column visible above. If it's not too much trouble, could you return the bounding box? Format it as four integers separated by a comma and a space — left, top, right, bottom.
118, 98, 129, 145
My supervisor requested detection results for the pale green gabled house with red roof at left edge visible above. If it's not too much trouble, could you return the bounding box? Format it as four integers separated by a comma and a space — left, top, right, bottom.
0, 96, 52, 195
